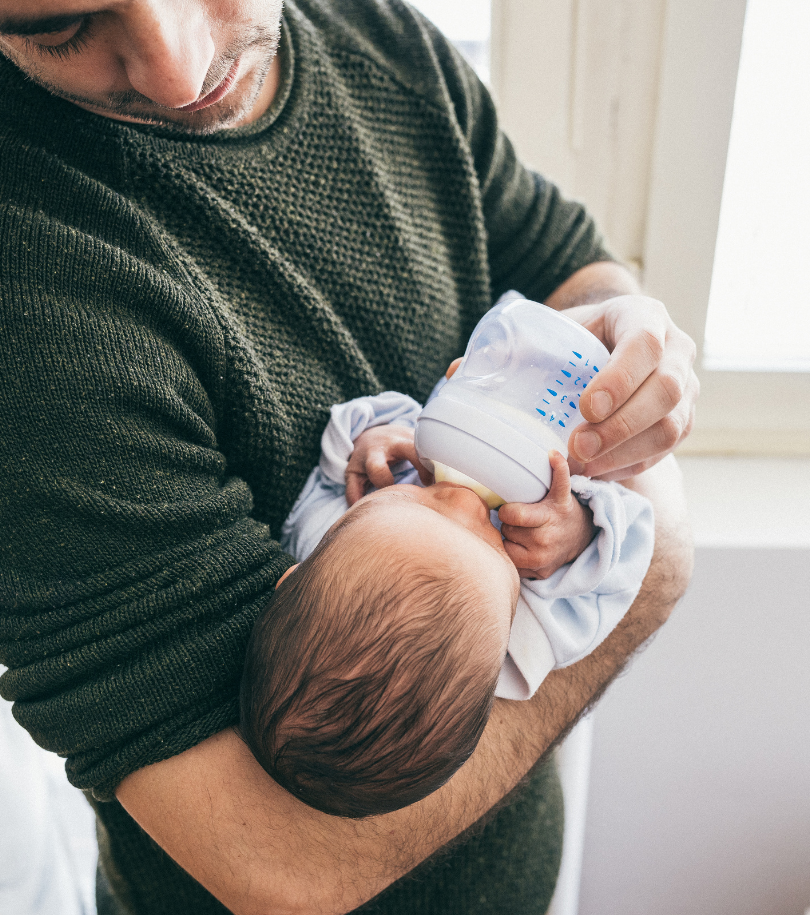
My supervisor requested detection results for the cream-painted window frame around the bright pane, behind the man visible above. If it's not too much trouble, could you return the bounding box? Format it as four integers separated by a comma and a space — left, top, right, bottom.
491, 0, 810, 456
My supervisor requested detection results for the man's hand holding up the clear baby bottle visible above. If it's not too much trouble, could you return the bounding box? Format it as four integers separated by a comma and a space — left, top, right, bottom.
546, 263, 700, 480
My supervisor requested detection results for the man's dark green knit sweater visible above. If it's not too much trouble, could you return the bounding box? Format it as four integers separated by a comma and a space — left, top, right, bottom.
0, 0, 607, 915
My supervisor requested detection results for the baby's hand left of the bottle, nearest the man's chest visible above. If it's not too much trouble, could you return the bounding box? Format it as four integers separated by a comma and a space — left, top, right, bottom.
346, 426, 433, 505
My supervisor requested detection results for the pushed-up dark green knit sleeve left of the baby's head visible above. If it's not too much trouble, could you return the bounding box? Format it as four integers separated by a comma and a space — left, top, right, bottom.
0, 214, 290, 800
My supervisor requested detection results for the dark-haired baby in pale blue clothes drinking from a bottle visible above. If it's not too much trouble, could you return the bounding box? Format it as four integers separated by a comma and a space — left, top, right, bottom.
241, 382, 653, 817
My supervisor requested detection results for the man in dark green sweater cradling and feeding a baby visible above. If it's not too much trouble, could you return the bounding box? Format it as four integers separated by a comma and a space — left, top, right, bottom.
0, 0, 697, 915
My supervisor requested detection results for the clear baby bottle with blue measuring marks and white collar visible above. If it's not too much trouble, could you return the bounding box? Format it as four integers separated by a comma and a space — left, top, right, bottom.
415, 296, 609, 508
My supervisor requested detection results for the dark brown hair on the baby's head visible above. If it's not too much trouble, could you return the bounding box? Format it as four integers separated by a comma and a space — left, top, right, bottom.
240, 503, 503, 817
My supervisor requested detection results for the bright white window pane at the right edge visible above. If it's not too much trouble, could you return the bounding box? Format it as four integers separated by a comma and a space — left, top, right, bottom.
704, 0, 810, 372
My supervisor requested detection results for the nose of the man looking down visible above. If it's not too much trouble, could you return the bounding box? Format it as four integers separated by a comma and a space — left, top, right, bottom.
121, 0, 215, 108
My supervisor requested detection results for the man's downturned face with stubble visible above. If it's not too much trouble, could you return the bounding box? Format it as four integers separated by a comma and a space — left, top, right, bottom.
0, 0, 282, 134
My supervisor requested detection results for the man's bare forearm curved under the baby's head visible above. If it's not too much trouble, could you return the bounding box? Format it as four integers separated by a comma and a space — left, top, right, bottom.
117, 458, 692, 915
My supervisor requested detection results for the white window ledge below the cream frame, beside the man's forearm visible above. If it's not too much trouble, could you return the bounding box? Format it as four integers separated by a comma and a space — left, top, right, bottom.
678, 456, 810, 549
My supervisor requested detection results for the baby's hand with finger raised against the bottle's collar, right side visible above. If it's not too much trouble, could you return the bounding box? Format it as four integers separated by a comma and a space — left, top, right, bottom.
498, 451, 596, 578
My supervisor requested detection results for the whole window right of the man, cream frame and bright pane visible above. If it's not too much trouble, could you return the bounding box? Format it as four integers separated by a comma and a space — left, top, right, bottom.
491, 0, 810, 456
